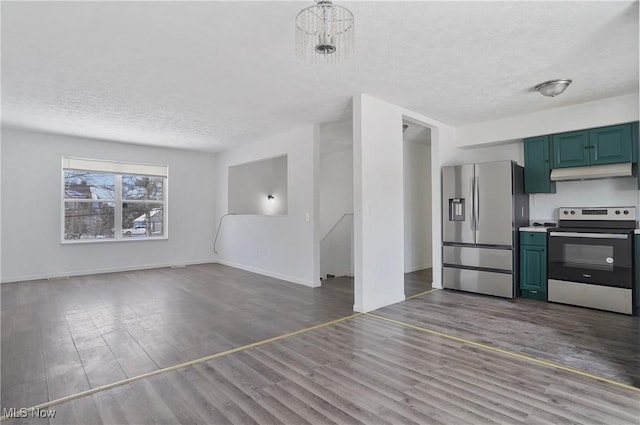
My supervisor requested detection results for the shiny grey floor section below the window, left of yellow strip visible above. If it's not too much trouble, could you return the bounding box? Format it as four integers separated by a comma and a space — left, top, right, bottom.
1, 264, 353, 407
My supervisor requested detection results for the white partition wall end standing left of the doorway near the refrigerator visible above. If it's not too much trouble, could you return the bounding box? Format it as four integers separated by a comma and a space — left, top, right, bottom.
353, 95, 404, 311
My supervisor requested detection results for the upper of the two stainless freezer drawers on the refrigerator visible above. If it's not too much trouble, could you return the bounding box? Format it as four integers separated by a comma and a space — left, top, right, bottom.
442, 246, 513, 271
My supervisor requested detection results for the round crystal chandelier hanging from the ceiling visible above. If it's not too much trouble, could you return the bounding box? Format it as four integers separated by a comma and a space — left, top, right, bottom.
296, 0, 354, 63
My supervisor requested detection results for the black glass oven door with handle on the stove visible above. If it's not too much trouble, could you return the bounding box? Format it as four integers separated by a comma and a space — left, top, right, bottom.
548, 229, 633, 289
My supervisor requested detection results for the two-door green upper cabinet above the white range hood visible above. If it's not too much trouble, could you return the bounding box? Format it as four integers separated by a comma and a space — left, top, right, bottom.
551, 123, 637, 168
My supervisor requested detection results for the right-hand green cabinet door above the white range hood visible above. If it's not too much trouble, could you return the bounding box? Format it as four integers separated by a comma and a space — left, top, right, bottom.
589, 124, 632, 165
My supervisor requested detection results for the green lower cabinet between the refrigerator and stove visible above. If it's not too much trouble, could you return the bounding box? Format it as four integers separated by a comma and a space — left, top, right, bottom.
520, 232, 547, 301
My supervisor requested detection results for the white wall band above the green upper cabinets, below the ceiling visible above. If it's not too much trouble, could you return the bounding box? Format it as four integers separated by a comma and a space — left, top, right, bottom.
456, 93, 640, 147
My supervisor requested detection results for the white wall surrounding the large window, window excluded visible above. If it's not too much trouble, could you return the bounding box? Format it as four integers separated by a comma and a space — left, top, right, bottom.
1, 129, 215, 282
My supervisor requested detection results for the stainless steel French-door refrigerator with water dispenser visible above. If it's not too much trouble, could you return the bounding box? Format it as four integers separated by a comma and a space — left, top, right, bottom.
442, 161, 529, 298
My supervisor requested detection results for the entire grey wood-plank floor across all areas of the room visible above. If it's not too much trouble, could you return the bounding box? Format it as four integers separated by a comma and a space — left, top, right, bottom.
2, 265, 640, 424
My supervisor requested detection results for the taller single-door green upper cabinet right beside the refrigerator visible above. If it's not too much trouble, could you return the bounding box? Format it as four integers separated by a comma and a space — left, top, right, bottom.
524, 136, 556, 193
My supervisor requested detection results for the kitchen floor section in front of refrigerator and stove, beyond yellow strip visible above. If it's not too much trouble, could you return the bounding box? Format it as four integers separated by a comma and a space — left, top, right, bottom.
376, 290, 640, 388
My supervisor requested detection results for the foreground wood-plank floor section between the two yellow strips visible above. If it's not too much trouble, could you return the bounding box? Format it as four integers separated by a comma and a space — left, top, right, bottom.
8, 315, 640, 424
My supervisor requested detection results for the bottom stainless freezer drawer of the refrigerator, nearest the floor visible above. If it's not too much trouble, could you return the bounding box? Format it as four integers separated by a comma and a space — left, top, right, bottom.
442, 267, 515, 298
